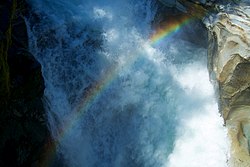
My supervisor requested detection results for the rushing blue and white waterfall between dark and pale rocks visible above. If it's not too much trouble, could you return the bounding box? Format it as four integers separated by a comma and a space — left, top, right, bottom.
27, 0, 228, 167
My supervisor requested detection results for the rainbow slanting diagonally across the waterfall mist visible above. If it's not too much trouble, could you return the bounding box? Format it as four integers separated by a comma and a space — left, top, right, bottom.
41, 17, 194, 166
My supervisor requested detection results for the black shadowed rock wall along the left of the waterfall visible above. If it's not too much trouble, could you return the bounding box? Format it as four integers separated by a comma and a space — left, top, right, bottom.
0, 0, 50, 167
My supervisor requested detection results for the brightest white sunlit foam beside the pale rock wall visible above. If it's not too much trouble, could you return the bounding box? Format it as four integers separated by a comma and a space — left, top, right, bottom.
167, 63, 229, 167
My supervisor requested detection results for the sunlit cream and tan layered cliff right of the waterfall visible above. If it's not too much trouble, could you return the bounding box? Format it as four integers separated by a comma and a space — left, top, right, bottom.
207, 5, 250, 167
